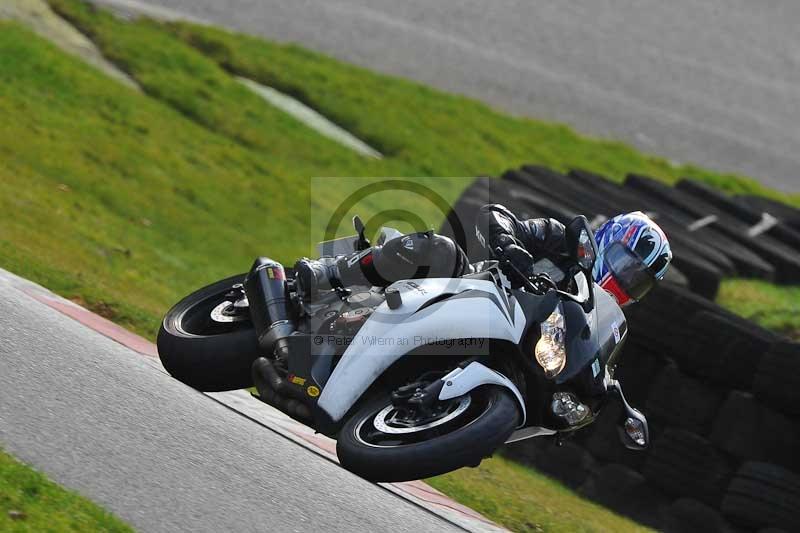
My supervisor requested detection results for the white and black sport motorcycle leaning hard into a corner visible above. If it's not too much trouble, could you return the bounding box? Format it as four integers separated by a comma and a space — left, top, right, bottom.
158, 216, 650, 481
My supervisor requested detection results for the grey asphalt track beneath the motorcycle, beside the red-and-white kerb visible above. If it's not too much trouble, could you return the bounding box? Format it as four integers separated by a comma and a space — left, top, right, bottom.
0, 270, 472, 532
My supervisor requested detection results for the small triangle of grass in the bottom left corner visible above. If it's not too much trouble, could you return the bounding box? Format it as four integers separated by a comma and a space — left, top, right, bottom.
0, 450, 133, 533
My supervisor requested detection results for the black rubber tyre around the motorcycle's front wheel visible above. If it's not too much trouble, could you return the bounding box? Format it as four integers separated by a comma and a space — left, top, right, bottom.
336, 386, 520, 482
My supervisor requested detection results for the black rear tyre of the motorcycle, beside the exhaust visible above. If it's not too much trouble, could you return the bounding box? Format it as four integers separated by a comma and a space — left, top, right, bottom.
157, 274, 260, 391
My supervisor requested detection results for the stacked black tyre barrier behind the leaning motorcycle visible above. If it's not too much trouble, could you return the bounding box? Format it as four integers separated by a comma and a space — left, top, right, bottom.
441, 165, 800, 532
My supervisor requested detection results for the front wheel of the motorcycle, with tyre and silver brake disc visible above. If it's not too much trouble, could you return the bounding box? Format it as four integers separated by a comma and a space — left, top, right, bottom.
336, 386, 520, 481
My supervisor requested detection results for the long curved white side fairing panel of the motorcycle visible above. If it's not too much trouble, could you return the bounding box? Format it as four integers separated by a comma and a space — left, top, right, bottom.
317, 278, 525, 421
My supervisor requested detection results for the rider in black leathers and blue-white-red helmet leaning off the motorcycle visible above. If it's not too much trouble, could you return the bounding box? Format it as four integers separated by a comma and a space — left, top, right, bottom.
295, 204, 672, 305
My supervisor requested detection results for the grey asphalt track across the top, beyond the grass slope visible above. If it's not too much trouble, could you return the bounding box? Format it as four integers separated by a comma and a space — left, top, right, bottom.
95, 0, 800, 192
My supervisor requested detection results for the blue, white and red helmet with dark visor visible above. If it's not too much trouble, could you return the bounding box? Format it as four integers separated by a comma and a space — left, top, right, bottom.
592, 211, 672, 306
